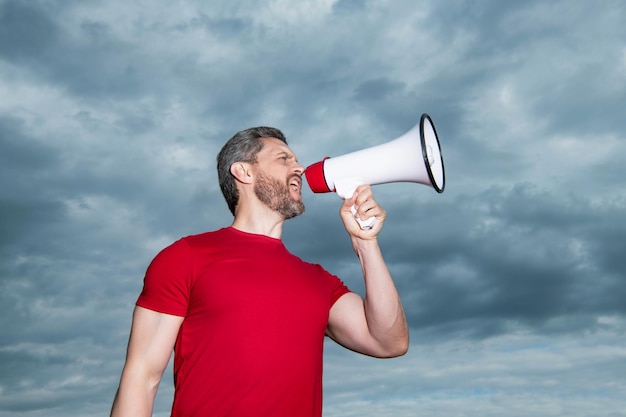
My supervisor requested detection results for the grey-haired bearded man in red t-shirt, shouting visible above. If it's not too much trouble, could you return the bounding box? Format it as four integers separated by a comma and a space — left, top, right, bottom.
111, 127, 408, 417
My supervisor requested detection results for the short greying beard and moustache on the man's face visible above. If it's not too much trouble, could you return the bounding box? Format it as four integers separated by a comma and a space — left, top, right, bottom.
254, 172, 304, 220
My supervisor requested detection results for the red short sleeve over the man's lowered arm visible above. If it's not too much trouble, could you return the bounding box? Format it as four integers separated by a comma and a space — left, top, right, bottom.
136, 239, 193, 317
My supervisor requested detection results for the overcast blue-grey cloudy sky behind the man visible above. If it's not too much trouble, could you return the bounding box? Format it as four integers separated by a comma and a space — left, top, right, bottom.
0, 0, 626, 417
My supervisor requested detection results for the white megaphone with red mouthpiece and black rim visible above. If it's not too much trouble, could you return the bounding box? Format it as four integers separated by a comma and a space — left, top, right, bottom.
304, 114, 445, 228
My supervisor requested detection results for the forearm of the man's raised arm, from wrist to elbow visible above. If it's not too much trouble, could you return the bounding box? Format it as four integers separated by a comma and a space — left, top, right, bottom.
352, 238, 409, 356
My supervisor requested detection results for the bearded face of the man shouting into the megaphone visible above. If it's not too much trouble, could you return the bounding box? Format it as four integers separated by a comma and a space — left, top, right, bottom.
254, 138, 304, 219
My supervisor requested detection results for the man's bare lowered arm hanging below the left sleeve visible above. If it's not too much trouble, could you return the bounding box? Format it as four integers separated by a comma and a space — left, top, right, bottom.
111, 307, 183, 417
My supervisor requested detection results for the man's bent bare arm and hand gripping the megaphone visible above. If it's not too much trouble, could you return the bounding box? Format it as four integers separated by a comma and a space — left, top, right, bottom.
327, 186, 409, 358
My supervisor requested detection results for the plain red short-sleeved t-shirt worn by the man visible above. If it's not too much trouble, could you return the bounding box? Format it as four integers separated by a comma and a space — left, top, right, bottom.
137, 227, 349, 417
